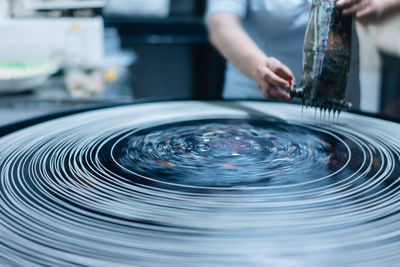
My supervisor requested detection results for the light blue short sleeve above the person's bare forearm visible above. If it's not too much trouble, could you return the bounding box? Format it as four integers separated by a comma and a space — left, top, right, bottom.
206, 0, 247, 21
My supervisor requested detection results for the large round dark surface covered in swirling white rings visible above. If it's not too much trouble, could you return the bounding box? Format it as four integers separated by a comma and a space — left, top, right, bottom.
0, 101, 400, 266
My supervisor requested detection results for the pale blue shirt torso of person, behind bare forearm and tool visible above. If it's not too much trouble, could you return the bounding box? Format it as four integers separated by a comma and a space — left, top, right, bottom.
224, 0, 312, 97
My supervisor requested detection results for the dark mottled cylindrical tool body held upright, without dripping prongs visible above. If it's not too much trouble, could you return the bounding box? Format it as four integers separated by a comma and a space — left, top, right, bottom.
292, 0, 352, 112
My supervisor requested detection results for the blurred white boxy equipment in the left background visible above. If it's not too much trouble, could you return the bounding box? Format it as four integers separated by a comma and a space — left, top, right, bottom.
0, 17, 104, 68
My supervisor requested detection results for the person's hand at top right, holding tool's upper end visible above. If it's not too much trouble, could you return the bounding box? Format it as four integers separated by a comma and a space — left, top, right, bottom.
337, 0, 400, 23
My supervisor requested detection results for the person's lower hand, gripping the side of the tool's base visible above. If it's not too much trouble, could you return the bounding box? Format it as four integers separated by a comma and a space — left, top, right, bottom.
255, 57, 296, 101
